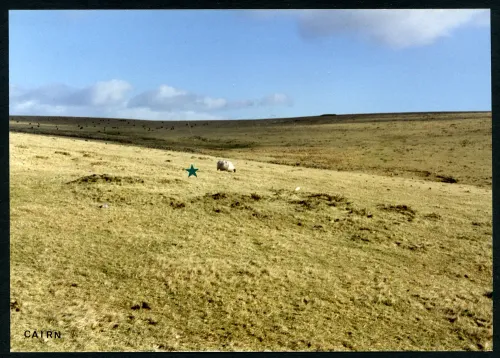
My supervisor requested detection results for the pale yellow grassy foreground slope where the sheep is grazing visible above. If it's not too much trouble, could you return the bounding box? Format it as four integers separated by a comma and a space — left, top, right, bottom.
10, 133, 492, 351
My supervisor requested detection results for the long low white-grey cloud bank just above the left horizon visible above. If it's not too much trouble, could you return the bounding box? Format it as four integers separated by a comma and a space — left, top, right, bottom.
9, 79, 293, 120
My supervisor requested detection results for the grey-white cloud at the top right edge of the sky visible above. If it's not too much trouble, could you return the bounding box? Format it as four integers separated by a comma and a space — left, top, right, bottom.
246, 9, 490, 49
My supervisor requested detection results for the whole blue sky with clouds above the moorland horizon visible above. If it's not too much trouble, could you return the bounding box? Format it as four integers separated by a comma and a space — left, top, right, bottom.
9, 9, 491, 120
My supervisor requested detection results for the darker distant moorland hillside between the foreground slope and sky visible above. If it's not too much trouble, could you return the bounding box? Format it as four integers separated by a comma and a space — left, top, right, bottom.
10, 112, 492, 188
